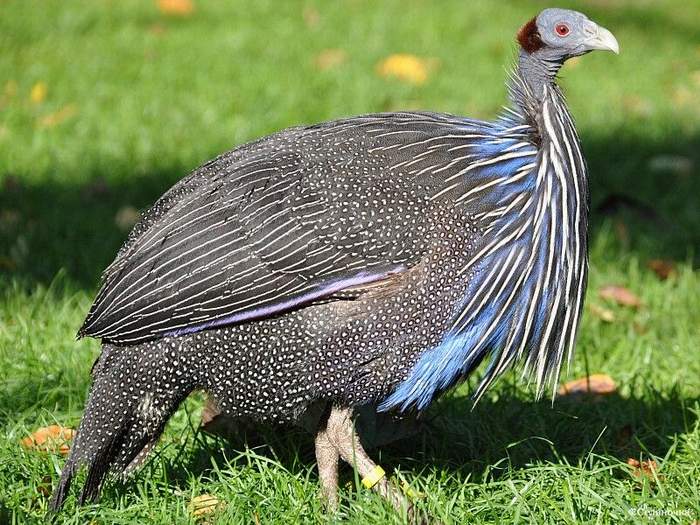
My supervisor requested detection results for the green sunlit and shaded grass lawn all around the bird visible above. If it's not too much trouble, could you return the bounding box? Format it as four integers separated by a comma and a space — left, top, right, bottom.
0, 0, 700, 523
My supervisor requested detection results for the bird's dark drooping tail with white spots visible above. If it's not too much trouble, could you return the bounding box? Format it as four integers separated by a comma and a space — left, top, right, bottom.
50, 345, 195, 511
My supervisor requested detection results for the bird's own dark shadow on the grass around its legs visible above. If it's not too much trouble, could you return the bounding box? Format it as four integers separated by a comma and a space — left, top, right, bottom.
104, 389, 700, 500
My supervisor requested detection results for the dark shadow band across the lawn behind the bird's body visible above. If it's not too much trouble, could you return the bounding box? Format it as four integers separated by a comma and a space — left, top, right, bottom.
0, 131, 700, 290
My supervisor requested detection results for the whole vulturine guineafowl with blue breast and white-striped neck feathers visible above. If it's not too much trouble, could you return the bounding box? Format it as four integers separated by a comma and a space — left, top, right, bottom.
52, 9, 618, 509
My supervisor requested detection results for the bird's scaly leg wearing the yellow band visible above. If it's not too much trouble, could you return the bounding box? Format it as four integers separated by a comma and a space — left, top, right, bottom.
326, 407, 411, 515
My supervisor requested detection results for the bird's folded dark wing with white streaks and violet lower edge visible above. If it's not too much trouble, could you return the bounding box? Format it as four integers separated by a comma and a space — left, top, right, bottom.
80, 115, 460, 343
